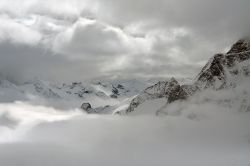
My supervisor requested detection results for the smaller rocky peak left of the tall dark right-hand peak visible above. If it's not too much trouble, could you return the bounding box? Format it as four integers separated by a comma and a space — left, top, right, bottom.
126, 78, 188, 113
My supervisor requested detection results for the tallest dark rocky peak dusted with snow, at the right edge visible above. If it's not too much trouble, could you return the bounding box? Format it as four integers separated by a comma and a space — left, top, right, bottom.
194, 40, 250, 90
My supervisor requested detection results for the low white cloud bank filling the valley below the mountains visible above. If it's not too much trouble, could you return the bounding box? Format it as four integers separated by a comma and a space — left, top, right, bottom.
0, 93, 250, 166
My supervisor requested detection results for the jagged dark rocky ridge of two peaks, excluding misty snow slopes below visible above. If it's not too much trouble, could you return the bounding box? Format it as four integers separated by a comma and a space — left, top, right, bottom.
126, 39, 250, 113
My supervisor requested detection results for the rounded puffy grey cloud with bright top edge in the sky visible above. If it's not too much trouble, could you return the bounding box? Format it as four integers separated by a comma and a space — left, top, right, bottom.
55, 19, 130, 58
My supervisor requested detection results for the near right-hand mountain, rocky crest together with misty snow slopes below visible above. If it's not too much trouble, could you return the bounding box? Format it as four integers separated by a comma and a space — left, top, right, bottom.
125, 40, 250, 114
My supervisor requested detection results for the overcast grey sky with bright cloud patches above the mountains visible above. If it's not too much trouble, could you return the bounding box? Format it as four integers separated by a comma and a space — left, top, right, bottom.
0, 0, 250, 82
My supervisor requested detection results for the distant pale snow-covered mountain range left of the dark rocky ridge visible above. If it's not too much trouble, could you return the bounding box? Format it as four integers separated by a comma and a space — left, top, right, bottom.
0, 75, 153, 112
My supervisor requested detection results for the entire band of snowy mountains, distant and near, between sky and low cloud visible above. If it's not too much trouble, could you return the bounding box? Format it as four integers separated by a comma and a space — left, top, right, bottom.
0, 40, 250, 114
